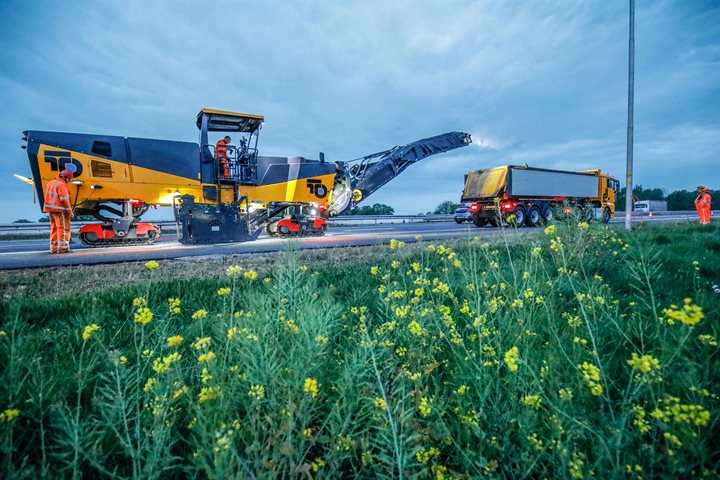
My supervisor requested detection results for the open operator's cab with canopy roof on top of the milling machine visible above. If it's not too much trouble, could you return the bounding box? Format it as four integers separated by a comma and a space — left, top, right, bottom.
197, 108, 264, 184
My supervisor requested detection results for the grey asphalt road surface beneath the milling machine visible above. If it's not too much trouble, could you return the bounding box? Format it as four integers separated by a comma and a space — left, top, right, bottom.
0, 215, 688, 270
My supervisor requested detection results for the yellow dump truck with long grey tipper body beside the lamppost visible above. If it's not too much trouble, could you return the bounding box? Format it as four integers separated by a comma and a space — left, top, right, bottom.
461, 165, 620, 227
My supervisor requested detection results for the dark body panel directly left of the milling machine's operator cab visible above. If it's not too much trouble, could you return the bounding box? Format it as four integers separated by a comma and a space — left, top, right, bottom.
127, 138, 200, 180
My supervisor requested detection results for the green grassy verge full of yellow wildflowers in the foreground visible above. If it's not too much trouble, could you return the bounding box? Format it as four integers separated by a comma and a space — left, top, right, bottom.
0, 224, 720, 478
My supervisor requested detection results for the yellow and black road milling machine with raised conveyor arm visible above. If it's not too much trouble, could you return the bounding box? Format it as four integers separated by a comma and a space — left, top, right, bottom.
23, 109, 472, 246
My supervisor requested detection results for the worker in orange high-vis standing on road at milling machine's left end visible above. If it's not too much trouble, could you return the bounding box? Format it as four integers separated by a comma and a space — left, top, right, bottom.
43, 170, 73, 253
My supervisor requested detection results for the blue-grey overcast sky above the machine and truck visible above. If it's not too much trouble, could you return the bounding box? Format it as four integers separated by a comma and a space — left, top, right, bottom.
0, 0, 720, 223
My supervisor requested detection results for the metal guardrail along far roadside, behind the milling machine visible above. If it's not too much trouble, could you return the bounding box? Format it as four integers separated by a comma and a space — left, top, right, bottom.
0, 210, 720, 237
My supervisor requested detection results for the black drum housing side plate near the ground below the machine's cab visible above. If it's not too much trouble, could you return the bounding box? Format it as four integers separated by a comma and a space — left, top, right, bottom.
174, 195, 262, 244
